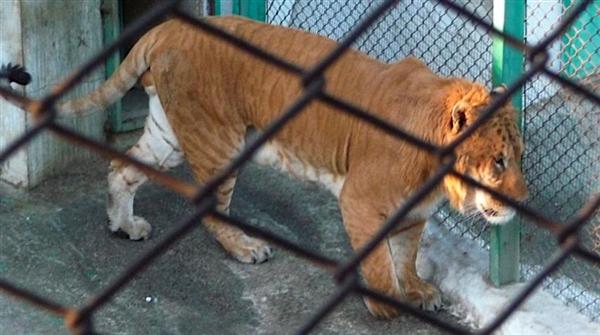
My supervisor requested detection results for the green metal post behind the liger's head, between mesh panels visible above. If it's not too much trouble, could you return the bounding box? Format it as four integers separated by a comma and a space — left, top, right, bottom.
490, 0, 526, 286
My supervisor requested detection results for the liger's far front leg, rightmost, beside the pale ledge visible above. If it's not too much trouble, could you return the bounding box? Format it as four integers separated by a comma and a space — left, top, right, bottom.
390, 221, 442, 311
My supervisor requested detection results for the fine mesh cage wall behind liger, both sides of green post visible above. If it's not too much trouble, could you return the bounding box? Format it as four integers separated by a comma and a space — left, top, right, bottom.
266, 0, 600, 320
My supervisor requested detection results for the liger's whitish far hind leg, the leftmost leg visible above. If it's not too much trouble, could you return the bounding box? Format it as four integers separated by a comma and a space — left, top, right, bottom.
107, 90, 184, 240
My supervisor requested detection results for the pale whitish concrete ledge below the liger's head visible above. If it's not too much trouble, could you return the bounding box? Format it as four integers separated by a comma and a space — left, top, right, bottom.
417, 222, 600, 335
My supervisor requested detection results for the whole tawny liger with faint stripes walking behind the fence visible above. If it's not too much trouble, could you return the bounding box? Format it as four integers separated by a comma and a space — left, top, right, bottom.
34, 18, 527, 317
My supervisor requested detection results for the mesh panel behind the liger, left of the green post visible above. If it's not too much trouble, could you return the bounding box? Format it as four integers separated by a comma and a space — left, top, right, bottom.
266, 0, 492, 246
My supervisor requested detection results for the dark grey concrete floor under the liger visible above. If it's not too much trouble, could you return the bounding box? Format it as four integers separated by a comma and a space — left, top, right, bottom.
0, 133, 460, 335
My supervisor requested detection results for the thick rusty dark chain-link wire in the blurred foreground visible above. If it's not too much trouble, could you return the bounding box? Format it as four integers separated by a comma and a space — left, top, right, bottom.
0, 0, 600, 334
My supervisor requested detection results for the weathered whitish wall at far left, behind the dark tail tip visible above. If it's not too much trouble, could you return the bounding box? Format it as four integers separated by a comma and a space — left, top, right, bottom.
0, 0, 106, 187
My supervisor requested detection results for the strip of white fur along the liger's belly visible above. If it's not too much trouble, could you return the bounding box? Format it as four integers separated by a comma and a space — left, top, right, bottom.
254, 141, 346, 198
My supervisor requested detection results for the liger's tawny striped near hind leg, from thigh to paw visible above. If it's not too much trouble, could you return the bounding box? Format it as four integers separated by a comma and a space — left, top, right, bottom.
152, 50, 271, 263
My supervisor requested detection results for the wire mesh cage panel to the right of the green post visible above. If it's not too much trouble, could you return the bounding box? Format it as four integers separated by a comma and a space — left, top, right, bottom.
521, 1, 600, 320
